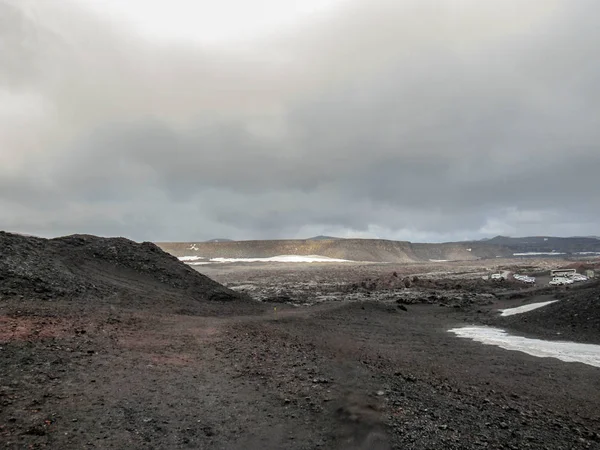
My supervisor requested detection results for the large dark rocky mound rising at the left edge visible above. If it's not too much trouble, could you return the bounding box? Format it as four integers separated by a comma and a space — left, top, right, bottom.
0, 232, 244, 310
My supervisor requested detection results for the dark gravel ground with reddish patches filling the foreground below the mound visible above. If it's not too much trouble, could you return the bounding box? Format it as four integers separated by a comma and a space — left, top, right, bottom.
0, 303, 600, 449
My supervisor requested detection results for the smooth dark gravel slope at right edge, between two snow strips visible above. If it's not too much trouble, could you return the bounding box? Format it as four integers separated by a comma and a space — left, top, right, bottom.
496, 282, 600, 344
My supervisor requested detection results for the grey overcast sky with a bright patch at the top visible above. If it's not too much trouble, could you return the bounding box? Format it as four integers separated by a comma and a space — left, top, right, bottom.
0, 0, 600, 242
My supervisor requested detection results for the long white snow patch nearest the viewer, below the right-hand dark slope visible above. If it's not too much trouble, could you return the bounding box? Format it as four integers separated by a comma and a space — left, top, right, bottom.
448, 326, 600, 367
